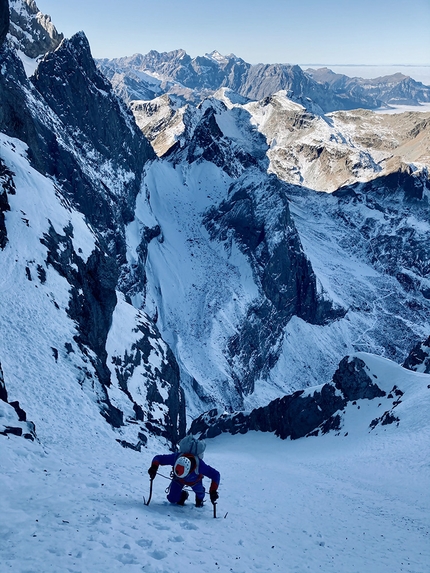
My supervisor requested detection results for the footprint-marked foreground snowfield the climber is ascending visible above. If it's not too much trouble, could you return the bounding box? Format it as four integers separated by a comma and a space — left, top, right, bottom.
0, 354, 430, 573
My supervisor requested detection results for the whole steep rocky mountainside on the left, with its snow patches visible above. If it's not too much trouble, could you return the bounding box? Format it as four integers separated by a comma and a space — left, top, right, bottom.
0, 2, 185, 449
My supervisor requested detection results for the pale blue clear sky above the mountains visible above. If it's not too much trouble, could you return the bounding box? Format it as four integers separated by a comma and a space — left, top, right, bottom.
36, 0, 430, 65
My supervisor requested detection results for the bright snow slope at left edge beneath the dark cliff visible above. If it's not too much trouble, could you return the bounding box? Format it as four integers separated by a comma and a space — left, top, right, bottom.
0, 135, 100, 441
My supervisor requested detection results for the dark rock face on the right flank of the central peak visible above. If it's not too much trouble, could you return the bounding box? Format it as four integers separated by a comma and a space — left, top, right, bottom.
204, 173, 344, 394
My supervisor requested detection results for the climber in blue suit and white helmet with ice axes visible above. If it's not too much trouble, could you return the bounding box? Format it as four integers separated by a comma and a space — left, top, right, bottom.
148, 435, 220, 507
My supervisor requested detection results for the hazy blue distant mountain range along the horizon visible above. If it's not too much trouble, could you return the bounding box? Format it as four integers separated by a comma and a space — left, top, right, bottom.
98, 50, 430, 112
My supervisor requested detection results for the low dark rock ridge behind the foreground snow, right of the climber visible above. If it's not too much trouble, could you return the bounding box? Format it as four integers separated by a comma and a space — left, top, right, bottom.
189, 356, 386, 440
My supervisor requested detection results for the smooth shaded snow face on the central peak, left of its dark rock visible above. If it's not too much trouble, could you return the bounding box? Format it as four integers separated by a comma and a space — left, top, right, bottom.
139, 162, 258, 415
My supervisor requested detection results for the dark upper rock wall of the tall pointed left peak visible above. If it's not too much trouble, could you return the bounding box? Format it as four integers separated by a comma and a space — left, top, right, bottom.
32, 33, 153, 227
